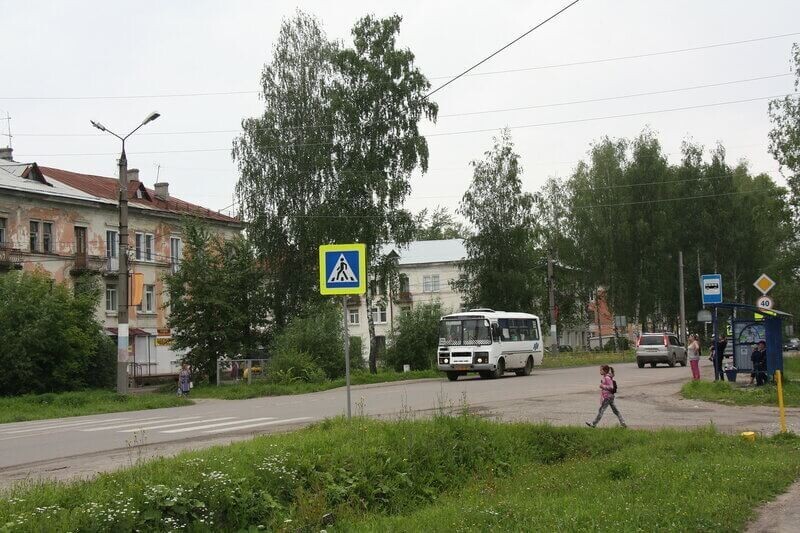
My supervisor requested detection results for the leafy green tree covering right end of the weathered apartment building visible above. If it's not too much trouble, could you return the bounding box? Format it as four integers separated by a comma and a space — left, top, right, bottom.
165, 221, 267, 380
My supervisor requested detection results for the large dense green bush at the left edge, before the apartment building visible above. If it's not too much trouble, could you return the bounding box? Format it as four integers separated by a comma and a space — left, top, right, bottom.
0, 272, 116, 395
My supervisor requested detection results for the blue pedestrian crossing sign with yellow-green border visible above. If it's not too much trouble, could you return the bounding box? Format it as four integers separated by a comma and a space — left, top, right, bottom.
319, 243, 367, 294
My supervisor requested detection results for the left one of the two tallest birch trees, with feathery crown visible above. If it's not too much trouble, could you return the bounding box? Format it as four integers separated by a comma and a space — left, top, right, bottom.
233, 12, 337, 328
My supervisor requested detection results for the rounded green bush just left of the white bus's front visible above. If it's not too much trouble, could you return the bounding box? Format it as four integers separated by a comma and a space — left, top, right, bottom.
384, 302, 446, 371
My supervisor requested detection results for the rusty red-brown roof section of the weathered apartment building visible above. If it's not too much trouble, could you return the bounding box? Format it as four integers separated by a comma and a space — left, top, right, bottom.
39, 167, 241, 224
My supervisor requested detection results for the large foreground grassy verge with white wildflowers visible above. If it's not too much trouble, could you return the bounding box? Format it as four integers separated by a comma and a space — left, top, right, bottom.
0, 416, 800, 531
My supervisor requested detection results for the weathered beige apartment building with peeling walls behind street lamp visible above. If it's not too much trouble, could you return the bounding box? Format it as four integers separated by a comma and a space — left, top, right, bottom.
0, 149, 242, 375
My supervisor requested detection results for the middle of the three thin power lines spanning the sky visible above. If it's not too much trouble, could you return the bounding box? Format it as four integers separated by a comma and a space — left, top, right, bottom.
14, 72, 794, 137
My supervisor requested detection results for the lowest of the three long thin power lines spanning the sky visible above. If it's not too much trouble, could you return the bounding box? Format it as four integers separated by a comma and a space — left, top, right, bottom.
19, 93, 800, 158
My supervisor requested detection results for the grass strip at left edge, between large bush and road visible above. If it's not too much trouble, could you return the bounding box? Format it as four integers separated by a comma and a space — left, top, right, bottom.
0, 390, 192, 424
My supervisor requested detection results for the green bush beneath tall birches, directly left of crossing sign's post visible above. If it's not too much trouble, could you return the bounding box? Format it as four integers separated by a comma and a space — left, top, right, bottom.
271, 300, 364, 378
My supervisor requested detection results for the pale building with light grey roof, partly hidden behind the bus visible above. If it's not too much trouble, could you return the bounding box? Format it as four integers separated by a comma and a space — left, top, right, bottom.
348, 239, 467, 357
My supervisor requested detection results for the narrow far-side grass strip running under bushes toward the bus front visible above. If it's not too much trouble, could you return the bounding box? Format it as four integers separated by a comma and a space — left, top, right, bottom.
181, 370, 444, 400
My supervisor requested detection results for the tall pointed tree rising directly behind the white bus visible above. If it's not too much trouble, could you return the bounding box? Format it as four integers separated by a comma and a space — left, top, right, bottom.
454, 130, 543, 311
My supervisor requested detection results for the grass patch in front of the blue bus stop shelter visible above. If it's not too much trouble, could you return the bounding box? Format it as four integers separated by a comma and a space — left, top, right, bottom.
681, 357, 800, 407
